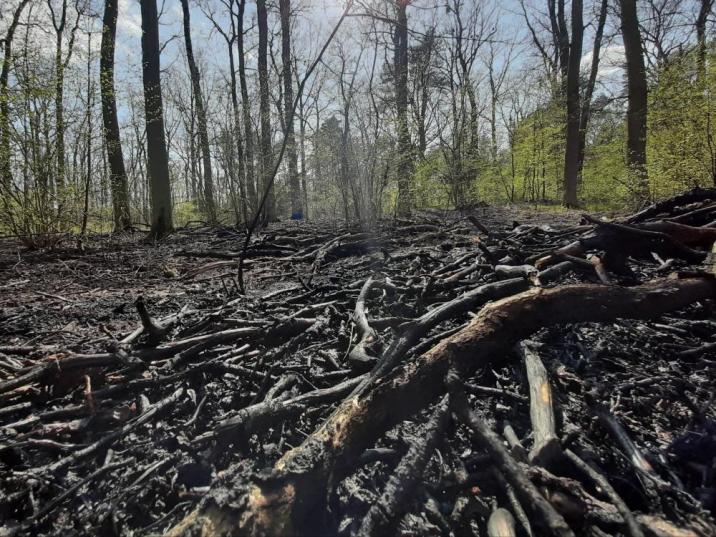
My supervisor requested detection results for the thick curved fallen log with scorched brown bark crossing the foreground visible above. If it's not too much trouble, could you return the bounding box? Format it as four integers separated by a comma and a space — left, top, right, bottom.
165, 277, 716, 536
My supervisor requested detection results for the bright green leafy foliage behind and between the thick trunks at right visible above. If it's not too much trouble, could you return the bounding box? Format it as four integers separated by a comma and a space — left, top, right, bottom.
442, 46, 716, 210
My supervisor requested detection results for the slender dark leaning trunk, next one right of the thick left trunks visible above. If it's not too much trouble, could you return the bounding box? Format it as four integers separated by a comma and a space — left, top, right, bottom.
181, 0, 216, 225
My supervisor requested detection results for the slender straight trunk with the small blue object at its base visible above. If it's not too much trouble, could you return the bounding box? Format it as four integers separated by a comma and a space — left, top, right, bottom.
279, 0, 303, 219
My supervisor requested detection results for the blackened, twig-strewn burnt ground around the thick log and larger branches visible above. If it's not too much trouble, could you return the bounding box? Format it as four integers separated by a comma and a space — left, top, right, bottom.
0, 202, 716, 535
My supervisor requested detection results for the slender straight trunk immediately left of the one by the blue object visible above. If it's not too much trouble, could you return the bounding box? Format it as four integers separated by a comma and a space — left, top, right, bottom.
256, 0, 276, 222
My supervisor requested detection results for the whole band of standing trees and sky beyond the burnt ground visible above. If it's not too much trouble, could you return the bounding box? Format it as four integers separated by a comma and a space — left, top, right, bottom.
0, 0, 716, 245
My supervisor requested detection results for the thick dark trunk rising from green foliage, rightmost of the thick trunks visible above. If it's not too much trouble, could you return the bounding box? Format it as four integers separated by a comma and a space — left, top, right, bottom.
620, 0, 649, 206
